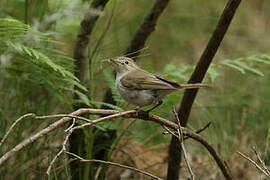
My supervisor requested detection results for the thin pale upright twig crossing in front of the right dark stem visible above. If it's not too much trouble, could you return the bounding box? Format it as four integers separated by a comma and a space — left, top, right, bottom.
173, 108, 195, 180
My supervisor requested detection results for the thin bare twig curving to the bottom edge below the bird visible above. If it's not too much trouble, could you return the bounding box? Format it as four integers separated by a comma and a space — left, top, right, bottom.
65, 151, 161, 180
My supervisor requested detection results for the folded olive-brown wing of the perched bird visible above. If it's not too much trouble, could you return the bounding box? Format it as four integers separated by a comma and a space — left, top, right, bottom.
120, 70, 180, 90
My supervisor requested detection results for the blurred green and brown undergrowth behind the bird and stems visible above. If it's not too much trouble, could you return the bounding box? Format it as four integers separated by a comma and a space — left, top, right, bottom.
0, 0, 270, 179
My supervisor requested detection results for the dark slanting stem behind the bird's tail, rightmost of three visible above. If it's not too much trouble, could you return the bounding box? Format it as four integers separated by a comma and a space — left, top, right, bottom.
167, 0, 241, 180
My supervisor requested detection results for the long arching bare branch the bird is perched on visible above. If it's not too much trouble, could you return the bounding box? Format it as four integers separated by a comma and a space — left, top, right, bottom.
0, 108, 230, 178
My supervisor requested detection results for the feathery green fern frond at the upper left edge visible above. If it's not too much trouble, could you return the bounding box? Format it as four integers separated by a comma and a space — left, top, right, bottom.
0, 19, 86, 104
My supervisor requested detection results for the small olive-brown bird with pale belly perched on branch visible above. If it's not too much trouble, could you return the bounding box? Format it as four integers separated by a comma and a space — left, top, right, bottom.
109, 56, 208, 112
